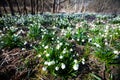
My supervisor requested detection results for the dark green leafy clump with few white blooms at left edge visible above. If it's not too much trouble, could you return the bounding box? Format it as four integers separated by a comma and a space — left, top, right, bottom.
0, 30, 23, 49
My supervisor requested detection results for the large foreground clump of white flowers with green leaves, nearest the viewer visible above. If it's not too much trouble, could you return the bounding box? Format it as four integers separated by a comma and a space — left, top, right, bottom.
39, 38, 82, 79
